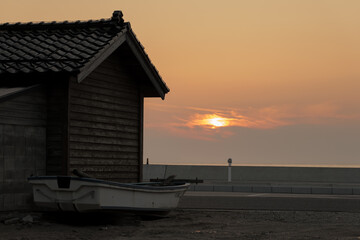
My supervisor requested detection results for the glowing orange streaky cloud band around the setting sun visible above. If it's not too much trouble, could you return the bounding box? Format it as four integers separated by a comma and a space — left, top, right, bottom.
146, 103, 360, 140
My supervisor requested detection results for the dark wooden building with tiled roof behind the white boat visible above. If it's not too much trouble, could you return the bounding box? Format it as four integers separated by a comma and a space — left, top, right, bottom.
0, 11, 169, 210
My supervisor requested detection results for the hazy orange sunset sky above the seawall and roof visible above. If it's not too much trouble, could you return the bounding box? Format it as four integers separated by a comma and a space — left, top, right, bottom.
0, 0, 360, 166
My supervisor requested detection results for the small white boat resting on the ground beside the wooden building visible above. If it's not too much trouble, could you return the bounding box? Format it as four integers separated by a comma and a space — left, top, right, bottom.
28, 176, 190, 213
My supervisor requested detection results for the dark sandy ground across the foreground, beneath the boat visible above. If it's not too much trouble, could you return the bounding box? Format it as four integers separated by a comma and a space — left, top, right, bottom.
0, 210, 360, 240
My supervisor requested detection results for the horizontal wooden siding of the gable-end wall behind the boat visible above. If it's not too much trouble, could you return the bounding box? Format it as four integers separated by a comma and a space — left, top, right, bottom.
69, 56, 143, 182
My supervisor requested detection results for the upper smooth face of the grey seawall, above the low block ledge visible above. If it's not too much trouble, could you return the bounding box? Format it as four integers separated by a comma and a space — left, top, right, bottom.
143, 164, 360, 184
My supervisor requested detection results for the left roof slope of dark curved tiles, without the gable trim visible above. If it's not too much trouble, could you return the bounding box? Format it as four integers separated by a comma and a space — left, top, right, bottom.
0, 11, 127, 74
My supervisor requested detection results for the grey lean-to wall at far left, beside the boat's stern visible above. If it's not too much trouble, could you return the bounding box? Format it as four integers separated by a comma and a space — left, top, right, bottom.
0, 88, 46, 211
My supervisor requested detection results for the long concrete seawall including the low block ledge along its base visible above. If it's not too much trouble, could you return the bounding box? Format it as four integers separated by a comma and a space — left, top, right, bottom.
143, 165, 360, 195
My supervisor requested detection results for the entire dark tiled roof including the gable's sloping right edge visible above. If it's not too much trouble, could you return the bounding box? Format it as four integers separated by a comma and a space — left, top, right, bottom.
0, 11, 169, 98
